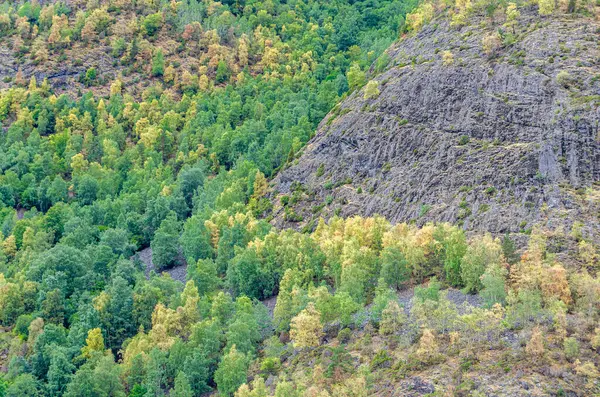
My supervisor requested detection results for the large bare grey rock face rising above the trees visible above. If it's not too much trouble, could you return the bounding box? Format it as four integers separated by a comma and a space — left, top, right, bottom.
275, 10, 600, 237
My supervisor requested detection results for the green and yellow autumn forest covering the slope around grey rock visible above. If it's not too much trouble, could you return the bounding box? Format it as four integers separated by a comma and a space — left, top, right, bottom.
0, 0, 600, 397
